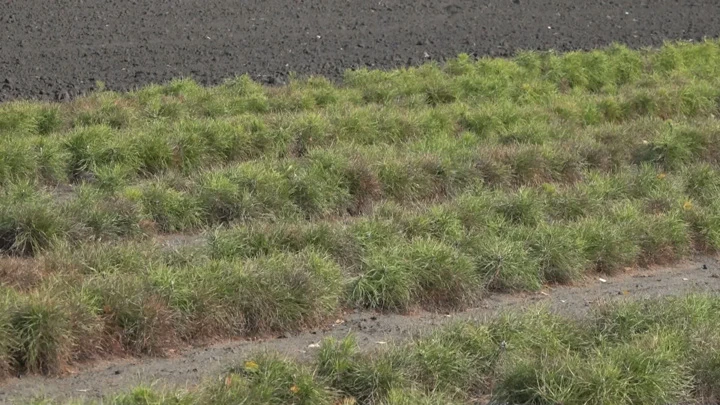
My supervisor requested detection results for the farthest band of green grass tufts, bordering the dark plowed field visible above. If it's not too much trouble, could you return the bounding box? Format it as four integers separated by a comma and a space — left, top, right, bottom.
0, 40, 720, 186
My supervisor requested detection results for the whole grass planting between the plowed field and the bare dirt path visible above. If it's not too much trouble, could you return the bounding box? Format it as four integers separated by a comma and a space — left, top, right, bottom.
0, 41, 720, 386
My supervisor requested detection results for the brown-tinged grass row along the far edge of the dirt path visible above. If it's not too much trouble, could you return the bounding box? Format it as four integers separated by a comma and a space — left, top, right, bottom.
0, 161, 720, 372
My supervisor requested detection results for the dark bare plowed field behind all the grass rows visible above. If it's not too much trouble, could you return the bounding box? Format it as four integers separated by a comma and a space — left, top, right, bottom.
0, 0, 720, 101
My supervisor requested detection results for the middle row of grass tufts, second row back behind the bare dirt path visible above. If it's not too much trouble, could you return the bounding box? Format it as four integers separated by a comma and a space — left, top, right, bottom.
0, 119, 720, 255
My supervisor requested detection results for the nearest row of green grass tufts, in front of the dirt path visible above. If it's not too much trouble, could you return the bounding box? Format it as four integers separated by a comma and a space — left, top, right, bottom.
21, 295, 720, 405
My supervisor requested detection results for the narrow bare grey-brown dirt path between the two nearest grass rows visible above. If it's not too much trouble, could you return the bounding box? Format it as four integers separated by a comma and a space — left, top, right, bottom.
0, 257, 720, 404
